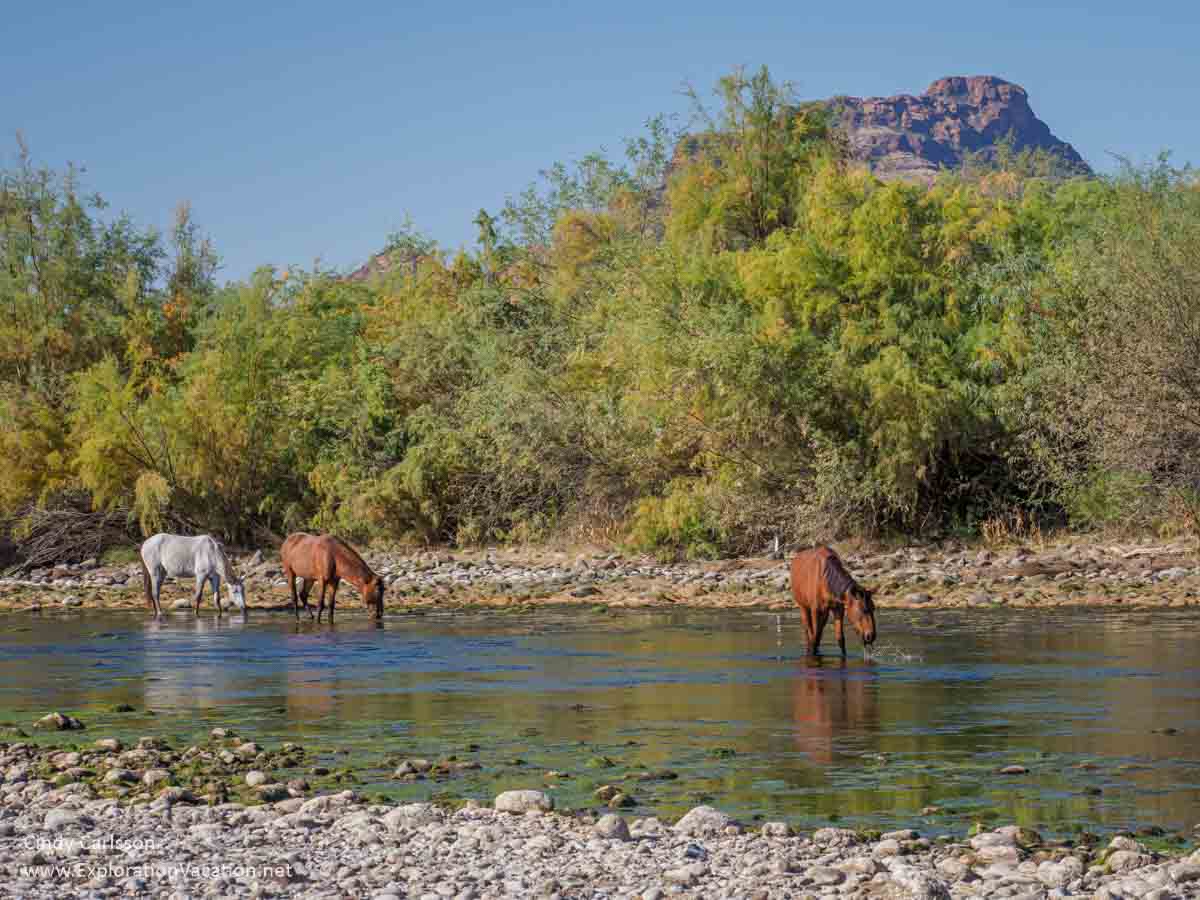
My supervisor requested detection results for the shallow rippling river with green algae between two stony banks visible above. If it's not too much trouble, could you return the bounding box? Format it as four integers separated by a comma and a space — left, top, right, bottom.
0, 608, 1200, 834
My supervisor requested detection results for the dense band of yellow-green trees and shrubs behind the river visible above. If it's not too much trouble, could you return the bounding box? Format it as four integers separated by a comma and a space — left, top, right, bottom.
0, 71, 1200, 557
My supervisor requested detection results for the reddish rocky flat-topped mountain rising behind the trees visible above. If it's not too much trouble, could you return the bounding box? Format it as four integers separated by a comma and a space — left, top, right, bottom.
829, 76, 1091, 179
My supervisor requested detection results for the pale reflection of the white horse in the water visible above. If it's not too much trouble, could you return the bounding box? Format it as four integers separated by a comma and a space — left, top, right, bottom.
143, 617, 246, 710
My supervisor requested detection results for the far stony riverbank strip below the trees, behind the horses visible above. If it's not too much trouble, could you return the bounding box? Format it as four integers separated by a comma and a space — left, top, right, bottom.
0, 539, 1200, 611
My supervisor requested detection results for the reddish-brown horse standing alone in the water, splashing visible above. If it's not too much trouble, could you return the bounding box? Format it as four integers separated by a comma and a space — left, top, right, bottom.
792, 547, 875, 656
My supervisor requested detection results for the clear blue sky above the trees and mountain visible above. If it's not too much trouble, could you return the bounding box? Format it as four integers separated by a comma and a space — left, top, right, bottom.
0, 0, 1200, 278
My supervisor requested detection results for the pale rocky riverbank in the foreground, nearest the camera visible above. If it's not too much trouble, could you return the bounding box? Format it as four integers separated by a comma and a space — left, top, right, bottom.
0, 722, 1200, 900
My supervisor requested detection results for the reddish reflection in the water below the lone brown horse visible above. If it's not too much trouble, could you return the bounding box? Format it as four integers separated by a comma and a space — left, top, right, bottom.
792, 656, 880, 764
